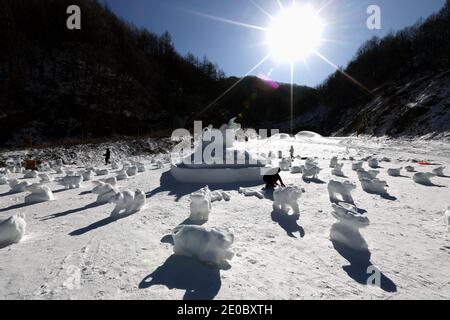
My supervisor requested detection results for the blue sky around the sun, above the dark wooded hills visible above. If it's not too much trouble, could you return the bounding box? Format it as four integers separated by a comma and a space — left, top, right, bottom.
103, 0, 445, 86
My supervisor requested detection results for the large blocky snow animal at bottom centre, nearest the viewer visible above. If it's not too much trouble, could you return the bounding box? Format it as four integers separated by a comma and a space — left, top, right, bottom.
173, 225, 234, 267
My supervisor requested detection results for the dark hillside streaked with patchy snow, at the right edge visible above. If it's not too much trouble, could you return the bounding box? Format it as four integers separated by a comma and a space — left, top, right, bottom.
335, 71, 450, 138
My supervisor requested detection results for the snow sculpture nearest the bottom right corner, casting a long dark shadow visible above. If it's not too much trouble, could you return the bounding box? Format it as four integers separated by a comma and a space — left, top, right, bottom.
330, 202, 370, 252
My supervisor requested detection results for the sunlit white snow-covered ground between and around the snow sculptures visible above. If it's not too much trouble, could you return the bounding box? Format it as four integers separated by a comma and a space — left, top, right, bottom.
0, 138, 450, 300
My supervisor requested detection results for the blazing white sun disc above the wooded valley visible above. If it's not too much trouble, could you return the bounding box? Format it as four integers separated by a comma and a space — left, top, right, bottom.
266, 5, 324, 63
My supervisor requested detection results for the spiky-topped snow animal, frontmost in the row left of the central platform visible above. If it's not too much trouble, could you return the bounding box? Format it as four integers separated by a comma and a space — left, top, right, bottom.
109, 190, 146, 218
